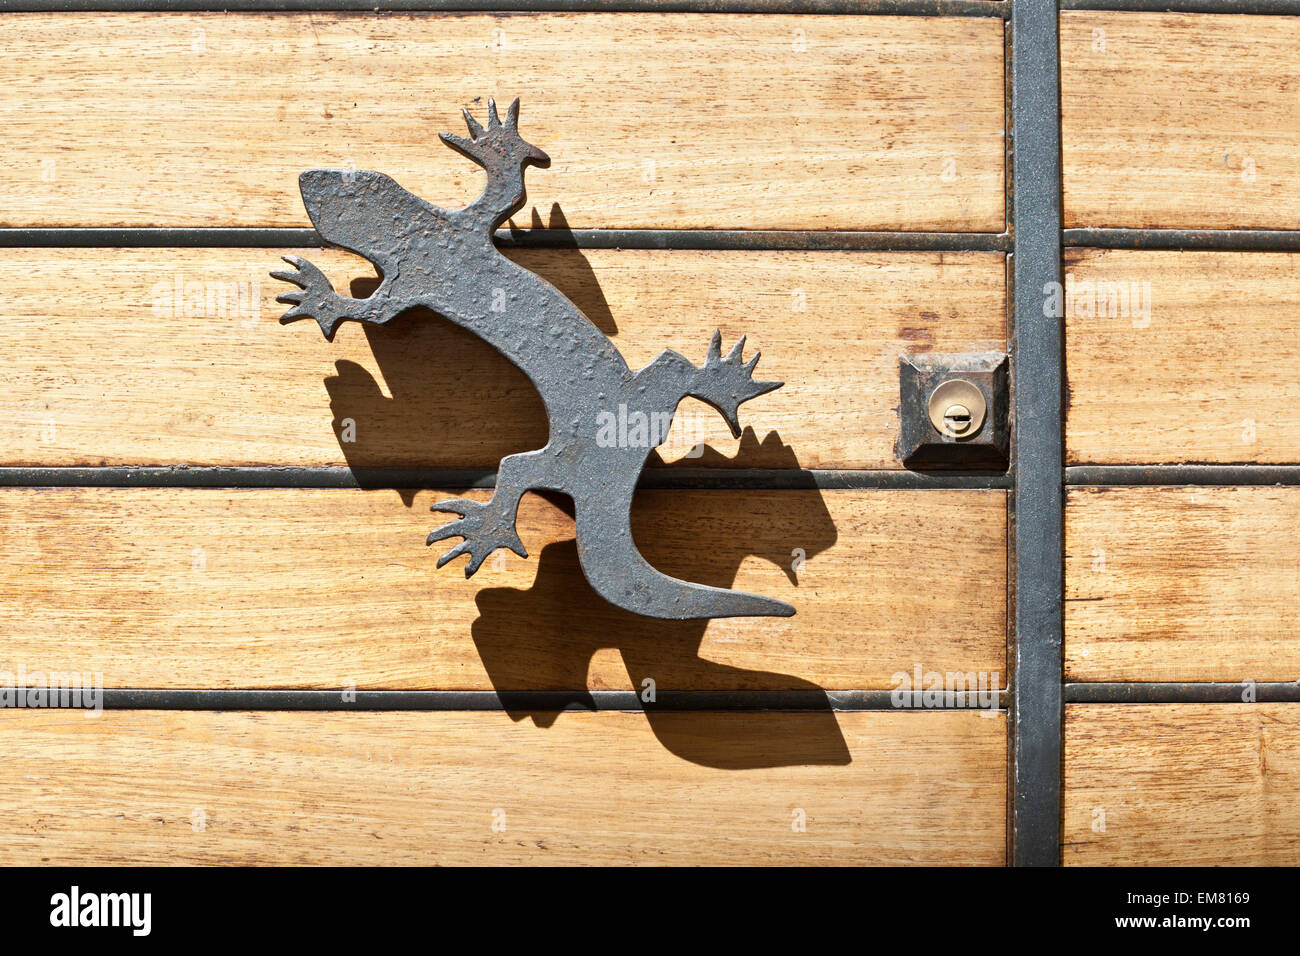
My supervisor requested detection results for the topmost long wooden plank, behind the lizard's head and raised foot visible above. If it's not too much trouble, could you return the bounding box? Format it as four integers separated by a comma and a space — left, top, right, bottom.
0, 13, 1005, 232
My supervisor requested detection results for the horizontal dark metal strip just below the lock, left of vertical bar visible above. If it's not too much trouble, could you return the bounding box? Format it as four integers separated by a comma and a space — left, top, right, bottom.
0, 466, 1011, 489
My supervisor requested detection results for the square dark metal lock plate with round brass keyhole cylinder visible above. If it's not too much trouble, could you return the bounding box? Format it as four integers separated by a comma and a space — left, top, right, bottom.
896, 352, 1010, 470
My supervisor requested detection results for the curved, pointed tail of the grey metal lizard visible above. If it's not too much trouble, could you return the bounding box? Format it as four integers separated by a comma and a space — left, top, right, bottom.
577, 499, 794, 620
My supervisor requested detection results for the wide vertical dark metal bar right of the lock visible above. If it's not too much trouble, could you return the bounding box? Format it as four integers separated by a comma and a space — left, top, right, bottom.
1011, 0, 1065, 866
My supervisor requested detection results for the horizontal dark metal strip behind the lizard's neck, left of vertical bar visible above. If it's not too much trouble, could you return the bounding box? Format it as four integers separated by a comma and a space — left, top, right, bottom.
0, 228, 1009, 252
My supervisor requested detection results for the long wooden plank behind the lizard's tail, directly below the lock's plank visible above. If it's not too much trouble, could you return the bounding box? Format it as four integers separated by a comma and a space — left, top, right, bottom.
0, 488, 1006, 691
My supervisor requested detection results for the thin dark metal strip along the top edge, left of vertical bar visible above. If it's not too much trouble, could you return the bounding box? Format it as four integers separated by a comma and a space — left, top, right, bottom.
0, 0, 1009, 17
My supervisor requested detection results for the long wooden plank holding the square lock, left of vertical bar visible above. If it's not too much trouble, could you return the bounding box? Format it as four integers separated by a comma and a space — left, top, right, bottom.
0, 247, 1006, 468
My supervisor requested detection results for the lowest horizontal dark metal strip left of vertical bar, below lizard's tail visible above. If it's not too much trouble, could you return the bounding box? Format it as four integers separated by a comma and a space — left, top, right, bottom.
0, 688, 1006, 711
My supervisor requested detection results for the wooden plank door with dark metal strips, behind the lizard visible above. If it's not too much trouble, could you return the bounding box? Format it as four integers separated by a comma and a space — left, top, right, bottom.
0, 0, 1300, 865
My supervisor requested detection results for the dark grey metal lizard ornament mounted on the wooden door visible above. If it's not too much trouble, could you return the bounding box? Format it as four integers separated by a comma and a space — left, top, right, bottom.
272, 99, 794, 619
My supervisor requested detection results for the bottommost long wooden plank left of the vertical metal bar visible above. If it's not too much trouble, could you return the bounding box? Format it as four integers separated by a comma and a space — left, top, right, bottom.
0, 710, 1006, 865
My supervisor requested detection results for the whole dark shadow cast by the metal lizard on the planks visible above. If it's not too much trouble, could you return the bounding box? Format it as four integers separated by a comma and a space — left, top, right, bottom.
325, 206, 852, 769
